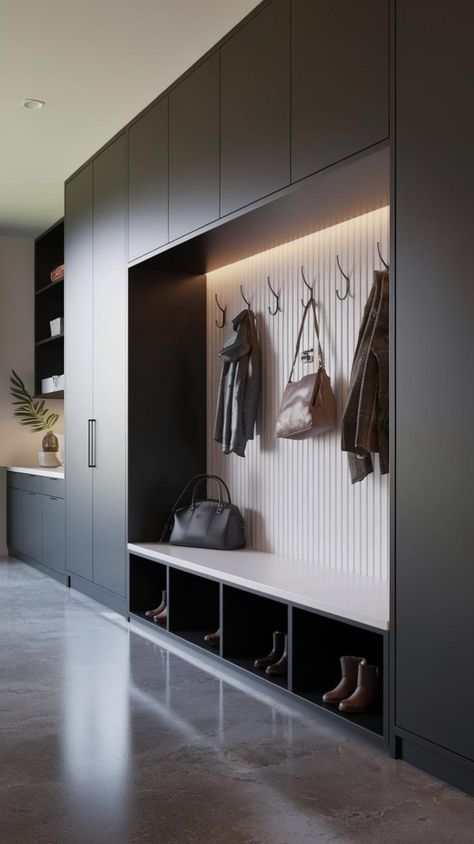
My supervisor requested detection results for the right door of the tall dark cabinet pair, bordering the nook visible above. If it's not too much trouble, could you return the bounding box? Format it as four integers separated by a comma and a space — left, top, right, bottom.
91, 134, 128, 596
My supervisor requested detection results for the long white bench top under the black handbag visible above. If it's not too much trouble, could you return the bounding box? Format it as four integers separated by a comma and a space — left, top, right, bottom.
128, 542, 390, 630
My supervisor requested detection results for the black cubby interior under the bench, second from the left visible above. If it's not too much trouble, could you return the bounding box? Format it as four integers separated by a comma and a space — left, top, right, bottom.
168, 568, 220, 652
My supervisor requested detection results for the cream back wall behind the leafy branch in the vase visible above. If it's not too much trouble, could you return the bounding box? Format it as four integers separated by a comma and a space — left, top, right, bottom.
0, 237, 64, 554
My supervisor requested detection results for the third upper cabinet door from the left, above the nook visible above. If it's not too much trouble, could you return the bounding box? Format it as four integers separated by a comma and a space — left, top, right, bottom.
221, 0, 290, 216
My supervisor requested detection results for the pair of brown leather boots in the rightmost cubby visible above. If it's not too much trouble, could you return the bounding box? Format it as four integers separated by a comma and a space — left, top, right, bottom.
323, 656, 380, 713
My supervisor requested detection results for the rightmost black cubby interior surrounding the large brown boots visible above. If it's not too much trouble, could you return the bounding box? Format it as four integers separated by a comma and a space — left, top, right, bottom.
292, 609, 384, 735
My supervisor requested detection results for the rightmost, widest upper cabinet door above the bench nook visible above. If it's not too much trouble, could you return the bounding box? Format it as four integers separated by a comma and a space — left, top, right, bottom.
291, 0, 389, 182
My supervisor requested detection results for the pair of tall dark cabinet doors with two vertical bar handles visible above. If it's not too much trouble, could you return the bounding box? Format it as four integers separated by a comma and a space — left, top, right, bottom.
65, 134, 127, 609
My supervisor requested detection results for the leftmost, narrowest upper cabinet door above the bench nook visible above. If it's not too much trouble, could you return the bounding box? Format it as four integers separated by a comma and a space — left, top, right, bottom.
128, 98, 168, 261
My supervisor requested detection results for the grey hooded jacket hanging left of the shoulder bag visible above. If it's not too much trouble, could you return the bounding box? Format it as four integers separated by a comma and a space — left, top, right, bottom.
214, 308, 260, 457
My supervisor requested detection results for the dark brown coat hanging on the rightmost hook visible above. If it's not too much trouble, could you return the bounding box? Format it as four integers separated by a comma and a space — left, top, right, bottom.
342, 270, 389, 484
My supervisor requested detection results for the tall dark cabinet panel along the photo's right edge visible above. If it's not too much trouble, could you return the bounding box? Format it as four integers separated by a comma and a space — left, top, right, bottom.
395, 0, 474, 764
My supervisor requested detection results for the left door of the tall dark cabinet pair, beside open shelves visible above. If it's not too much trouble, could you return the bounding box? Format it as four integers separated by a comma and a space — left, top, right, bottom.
64, 164, 93, 580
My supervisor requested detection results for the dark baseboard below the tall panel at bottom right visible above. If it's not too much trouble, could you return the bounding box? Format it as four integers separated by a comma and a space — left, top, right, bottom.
397, 731, 474, 797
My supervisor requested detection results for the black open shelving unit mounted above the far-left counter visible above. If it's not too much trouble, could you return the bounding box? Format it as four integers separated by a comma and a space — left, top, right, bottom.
35, 220, 64, 399
